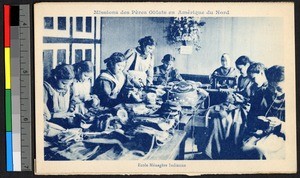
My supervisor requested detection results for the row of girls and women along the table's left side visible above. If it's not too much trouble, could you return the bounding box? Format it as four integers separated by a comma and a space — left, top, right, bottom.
44, 36, 181, 131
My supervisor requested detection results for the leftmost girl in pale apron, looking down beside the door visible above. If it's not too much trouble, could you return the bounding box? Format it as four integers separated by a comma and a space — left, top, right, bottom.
44, 64, 76, 128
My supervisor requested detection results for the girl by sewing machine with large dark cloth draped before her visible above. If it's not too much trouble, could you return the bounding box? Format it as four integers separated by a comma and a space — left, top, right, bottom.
205, 56, 253, 159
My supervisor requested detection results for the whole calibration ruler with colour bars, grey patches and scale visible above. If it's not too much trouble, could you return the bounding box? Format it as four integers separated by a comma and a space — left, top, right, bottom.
4, 5, 32, 171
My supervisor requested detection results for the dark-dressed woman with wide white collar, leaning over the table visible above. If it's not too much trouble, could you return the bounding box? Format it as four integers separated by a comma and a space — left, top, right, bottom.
93, 52, 126, 107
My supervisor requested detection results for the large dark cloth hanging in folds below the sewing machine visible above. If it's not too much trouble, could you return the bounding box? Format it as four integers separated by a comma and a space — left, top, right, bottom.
205, 104, 247, 159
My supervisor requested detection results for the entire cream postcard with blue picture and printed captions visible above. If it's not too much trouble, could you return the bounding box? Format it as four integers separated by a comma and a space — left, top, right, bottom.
34, 2, 297, 175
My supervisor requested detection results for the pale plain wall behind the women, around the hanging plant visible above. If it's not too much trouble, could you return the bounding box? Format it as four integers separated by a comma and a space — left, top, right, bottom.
101, 17, 284, 75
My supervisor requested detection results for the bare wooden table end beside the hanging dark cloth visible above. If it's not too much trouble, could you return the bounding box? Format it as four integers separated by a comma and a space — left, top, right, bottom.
148, 130, 186, 160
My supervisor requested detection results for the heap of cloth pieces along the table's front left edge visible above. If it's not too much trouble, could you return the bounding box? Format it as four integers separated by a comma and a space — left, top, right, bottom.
45, 121, 158, 160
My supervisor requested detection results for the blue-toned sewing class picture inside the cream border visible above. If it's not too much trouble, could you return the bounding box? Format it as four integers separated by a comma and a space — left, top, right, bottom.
41, 16, 286, 161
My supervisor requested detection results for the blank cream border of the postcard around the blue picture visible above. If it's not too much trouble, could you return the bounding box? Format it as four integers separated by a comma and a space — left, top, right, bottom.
34, 2, 297, 175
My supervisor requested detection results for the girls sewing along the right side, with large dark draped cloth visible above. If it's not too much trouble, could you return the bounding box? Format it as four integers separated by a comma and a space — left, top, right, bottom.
204, 56, 285, 159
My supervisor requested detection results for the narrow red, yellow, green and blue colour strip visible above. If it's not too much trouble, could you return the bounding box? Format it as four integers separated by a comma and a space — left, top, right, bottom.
4, 5, 13, 171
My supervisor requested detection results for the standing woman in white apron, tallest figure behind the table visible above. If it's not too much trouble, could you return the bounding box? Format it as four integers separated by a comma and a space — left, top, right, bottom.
124, 36, 156, 87
